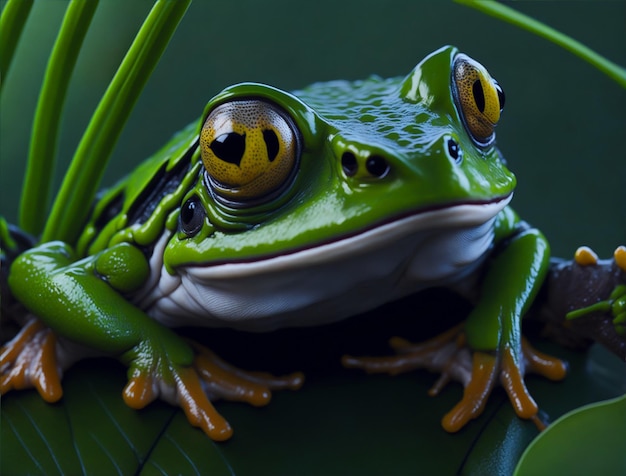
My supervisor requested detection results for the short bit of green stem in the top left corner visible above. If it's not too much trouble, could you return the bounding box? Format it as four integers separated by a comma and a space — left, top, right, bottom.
0, 0, 33, 88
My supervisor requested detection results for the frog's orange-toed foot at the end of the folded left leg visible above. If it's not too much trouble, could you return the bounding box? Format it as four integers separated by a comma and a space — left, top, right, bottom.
123, 342, 304, 441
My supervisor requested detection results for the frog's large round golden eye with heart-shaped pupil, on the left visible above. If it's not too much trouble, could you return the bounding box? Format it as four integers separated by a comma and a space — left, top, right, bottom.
200, 99, 300, 206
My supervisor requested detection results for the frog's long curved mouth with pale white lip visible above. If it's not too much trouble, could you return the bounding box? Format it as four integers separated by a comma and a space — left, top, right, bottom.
182, 193, 513, 280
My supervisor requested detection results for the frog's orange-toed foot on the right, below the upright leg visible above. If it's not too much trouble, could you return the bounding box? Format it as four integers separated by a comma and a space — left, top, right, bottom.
343, 325, 567, 433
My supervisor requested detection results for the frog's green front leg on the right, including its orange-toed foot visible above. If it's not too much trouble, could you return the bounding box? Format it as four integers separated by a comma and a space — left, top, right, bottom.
344, 225, 566, 432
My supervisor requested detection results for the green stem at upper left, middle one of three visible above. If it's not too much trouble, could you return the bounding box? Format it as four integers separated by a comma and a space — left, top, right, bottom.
19, 0, 98, 235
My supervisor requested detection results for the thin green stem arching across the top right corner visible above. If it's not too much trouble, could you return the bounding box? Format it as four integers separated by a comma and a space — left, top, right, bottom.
455, 0, 626, 88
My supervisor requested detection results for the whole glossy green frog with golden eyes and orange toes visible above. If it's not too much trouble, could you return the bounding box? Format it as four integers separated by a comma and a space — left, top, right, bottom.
0, 46, 567, 441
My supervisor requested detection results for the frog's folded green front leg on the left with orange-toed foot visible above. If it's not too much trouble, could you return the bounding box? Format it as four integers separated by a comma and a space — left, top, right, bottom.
2, 242, 302, 440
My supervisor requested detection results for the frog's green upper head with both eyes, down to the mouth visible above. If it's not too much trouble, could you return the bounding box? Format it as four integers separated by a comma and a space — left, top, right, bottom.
164, 47, 515, 274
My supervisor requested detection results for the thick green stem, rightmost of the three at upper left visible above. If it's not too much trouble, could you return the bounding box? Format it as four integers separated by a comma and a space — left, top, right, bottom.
42, 0, 190, 243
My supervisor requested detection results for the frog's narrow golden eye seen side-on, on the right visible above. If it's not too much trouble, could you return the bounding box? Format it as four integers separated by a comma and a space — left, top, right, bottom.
452, 54, 504, 145
